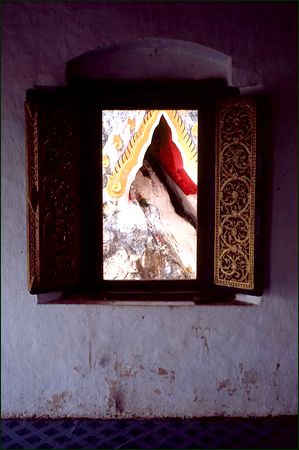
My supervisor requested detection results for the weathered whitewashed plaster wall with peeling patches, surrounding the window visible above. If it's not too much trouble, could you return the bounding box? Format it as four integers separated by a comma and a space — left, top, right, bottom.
1, 1, 298, 417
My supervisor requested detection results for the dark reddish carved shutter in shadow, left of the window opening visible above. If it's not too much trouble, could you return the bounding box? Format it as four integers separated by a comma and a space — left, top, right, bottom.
25, 91, 81, 294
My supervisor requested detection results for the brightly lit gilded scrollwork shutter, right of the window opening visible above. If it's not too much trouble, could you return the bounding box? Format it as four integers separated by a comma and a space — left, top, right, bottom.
214, 97, 256, 290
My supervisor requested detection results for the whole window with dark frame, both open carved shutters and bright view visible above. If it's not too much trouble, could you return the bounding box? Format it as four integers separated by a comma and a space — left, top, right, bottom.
26, 80, 261, 299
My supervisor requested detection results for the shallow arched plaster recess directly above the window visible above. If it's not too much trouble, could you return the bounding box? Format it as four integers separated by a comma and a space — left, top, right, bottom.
66, 38, 232, 85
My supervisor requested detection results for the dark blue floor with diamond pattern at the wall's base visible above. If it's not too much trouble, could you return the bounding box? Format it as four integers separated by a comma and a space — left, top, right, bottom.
1, 416, 298, 449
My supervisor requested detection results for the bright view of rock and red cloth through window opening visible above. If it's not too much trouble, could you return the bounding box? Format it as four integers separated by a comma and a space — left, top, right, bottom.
102, 110, 198, 280
